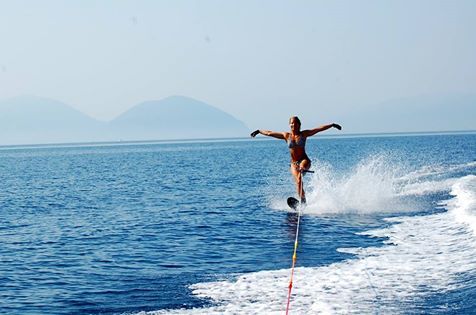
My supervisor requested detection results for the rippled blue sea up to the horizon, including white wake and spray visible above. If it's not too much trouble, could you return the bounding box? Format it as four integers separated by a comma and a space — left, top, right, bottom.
0, 133, 476, 314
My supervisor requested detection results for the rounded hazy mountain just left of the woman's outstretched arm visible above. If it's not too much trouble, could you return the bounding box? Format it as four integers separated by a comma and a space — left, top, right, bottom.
110, 96, 249, 140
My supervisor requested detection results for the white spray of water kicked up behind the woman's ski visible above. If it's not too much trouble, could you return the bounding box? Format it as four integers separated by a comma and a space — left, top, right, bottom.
270, 154, 476, 215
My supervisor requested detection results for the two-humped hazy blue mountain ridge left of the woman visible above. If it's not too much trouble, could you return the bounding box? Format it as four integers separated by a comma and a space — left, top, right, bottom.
0, 96, 249, 145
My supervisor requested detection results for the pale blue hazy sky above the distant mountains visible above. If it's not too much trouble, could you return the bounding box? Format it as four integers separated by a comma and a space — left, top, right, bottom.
0, 0, 476, 131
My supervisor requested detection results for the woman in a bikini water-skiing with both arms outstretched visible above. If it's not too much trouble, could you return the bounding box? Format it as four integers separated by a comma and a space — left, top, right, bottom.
251, 116, 342, 204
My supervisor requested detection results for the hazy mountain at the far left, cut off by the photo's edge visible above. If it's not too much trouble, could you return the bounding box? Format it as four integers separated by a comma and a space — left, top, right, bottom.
0, 96, 105, 145
